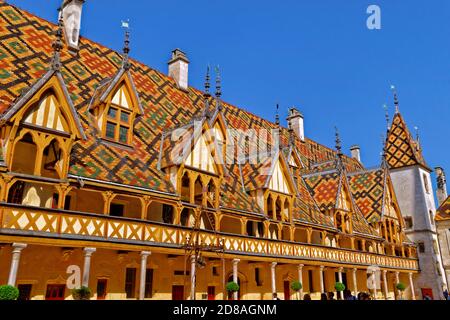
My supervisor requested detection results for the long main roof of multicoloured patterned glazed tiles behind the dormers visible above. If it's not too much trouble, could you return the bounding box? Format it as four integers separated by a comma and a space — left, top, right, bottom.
0, 2, 380, 233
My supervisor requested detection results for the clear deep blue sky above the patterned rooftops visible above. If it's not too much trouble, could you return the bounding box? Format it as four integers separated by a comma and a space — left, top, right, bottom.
8, 0, 450, 182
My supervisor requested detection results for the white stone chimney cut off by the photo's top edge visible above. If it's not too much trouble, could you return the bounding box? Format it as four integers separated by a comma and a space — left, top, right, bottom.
60, 0, 85, 51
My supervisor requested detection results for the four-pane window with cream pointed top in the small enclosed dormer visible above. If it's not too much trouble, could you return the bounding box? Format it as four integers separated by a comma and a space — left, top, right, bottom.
105, 85, 133, 144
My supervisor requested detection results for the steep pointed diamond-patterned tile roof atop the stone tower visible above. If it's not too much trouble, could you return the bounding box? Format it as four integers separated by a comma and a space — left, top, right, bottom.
386, 112, 428, 168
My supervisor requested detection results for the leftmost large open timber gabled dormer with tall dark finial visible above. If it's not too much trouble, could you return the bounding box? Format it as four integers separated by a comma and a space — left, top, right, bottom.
1, 22, 85, 179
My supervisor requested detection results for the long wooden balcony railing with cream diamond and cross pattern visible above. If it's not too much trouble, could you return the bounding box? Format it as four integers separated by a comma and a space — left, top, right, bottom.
0, 204, 418, 270
